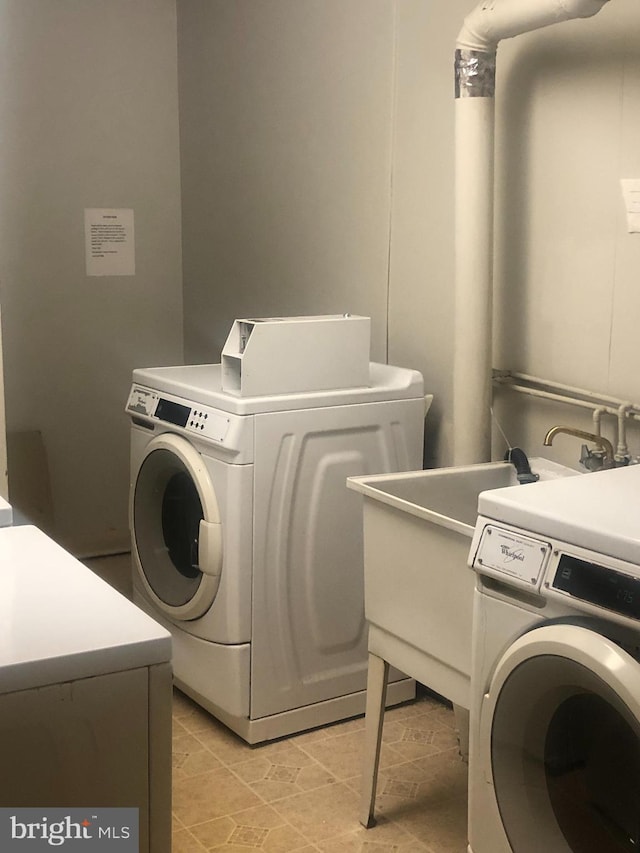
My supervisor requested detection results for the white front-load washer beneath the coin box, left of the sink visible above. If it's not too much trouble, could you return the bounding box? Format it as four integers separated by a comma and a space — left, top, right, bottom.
127, 363, 430, 743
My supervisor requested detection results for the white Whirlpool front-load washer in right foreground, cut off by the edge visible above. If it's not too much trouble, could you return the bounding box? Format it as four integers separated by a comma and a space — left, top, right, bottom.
469, 466, 640, 853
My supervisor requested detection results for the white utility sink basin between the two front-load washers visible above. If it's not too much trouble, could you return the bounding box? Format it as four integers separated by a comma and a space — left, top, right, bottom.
347, 458, 579, 708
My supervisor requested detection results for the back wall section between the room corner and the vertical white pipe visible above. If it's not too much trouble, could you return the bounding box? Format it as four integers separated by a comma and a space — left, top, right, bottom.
178, 0, 469, 464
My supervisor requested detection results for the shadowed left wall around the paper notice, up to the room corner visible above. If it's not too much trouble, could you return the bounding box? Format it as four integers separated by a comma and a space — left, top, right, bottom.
0, 0, 182, 554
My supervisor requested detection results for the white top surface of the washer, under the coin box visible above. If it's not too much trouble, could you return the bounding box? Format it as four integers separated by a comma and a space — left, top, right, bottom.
133, 362, 424, 415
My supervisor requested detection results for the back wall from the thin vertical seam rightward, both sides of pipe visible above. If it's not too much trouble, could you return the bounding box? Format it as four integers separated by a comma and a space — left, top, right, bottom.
389, 0, 640, 464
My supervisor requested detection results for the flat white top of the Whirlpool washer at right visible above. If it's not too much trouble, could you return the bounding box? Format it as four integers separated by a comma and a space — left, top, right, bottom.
478, 465, 640, 565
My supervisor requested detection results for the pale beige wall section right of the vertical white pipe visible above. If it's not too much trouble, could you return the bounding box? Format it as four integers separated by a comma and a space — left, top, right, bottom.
494, 0, 640, 463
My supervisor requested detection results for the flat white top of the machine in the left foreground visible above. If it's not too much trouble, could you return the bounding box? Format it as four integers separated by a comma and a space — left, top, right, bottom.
0, 526, 171, 693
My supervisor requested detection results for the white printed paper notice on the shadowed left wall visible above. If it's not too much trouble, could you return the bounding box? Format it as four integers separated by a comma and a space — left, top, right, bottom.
84, 207, 136, 275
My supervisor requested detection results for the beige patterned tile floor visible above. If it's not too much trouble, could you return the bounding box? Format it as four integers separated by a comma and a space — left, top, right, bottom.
85, 555, 467, 853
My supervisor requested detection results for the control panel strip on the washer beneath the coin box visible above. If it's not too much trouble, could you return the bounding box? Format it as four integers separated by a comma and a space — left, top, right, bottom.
126, 385, 230, 443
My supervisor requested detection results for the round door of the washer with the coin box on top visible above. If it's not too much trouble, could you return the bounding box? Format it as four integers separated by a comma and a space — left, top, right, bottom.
132, 433, 222, 620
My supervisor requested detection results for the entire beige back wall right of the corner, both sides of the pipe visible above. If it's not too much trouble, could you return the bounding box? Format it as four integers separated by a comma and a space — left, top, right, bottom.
178, 0, 640, 465
